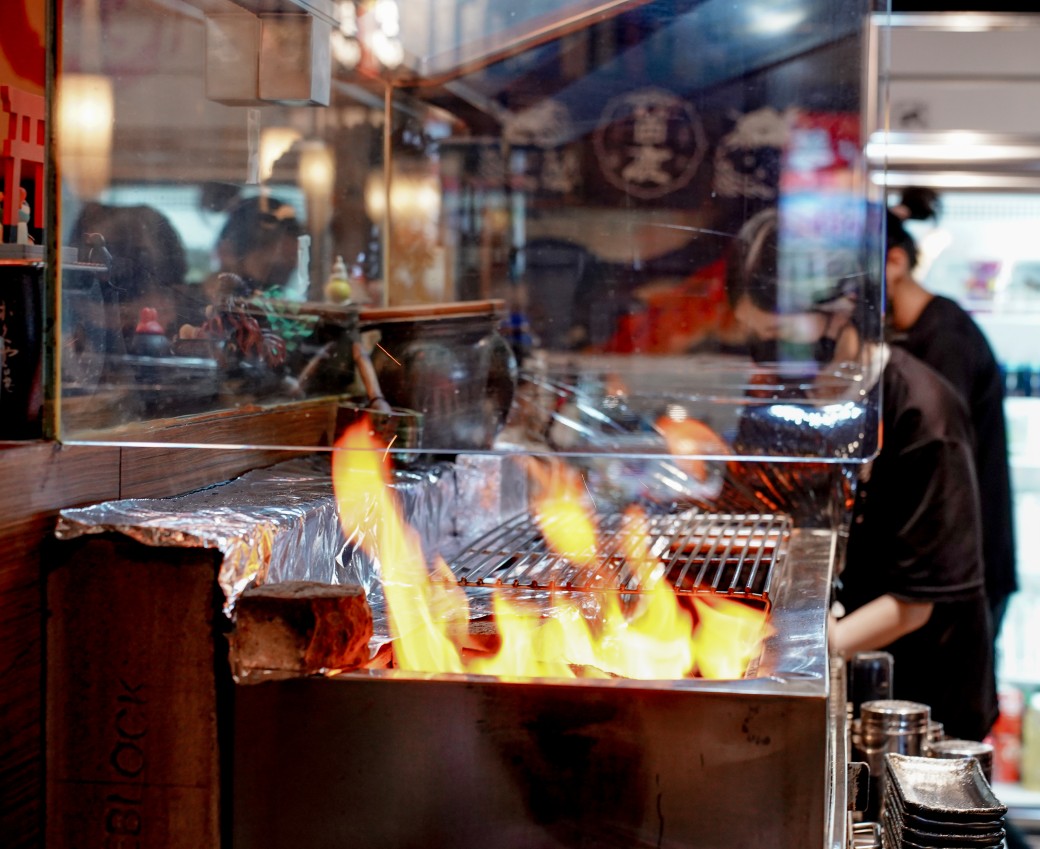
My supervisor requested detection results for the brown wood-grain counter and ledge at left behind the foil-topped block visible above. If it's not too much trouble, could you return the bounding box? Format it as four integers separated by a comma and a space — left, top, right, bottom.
0, 401, 336, 849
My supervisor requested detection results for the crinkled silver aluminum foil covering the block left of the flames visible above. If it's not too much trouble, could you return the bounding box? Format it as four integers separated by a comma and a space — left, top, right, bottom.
55, 454, 486, 616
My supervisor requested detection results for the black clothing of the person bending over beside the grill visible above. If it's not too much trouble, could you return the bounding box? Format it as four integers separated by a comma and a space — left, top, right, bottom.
837, 349, 996, 740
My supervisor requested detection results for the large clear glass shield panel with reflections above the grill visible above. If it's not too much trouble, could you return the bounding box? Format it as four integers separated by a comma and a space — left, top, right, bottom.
53, 0, 882, 468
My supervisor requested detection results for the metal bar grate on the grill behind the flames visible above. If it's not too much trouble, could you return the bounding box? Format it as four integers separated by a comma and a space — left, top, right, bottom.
443, 511, 791, 608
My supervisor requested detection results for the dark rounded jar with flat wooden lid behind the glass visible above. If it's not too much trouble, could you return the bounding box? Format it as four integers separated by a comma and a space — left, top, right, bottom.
361, 301, 517, 453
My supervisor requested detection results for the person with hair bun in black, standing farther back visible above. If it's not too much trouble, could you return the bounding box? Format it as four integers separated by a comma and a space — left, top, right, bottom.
886, 200, 1018, 637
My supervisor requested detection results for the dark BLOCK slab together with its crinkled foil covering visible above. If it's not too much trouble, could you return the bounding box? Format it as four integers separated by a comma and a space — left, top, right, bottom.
46, 455, 512, 849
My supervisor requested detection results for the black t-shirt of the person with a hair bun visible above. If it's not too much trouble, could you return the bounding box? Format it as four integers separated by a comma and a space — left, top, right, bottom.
893, 297, 1018, 601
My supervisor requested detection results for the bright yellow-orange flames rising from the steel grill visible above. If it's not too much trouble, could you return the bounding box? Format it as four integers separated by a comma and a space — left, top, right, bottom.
333, 420, 765, 679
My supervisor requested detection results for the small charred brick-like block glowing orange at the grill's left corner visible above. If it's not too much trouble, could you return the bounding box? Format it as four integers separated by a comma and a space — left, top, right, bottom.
229, 581, 372, 680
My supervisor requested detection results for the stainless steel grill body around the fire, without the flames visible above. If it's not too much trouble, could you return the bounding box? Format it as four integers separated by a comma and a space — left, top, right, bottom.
231, 524, 848, 849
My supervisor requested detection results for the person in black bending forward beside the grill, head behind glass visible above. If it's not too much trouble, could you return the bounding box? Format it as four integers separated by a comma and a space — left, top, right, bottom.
727, 210, 997, 740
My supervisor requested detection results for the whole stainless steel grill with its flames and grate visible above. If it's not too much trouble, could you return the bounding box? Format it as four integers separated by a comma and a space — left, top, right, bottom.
232, 436, 847, 849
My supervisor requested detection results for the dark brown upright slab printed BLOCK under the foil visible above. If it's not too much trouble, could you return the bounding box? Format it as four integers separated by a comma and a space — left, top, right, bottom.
47, 534, 231, 849
